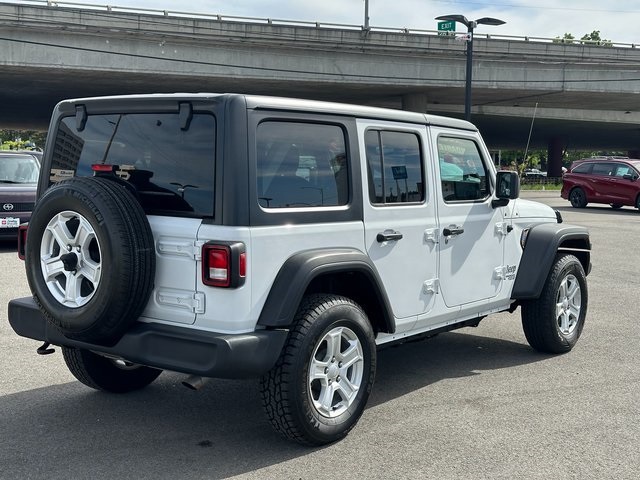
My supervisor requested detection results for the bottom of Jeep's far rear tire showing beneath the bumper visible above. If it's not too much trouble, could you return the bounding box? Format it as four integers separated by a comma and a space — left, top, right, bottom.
62, 347, 162, 393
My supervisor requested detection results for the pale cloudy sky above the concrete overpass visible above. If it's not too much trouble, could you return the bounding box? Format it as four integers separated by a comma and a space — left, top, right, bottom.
22, 0, 640, 44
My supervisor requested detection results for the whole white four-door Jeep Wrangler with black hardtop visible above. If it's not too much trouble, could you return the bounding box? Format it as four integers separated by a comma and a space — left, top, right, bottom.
9, 94, 591, 445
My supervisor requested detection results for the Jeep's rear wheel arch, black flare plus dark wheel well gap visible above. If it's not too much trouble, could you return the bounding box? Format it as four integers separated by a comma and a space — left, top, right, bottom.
258, 248, 395, 333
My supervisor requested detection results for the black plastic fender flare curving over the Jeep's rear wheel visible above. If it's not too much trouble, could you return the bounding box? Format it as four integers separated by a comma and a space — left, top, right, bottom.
258, 248, 396, 333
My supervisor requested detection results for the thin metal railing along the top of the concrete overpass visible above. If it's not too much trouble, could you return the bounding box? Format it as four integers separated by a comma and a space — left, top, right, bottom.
8, 0, 640, 48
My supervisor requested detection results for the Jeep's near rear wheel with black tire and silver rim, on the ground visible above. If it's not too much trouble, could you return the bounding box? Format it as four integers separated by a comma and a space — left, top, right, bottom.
261, 295, 376, 445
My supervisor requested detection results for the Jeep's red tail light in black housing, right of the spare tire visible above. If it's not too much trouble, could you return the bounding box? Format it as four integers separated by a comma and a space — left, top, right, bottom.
202, 242, 247, 288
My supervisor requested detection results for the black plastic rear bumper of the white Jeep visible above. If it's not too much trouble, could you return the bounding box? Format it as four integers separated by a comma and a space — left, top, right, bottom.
9, 297, 288, 378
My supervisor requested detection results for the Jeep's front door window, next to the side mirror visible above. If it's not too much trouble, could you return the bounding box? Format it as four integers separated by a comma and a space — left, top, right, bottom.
438, 137, 490, 202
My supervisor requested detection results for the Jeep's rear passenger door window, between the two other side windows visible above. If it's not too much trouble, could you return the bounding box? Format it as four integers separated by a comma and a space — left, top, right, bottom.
365, 130, 425, 204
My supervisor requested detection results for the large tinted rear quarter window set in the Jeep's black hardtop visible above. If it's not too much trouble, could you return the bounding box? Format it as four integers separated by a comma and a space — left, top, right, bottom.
256, 121, 349, 208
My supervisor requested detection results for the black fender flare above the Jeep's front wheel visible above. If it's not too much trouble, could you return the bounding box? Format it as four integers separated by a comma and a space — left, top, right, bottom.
511, 223, 591, 300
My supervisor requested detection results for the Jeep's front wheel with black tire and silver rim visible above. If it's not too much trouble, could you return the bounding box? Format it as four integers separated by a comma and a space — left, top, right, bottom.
521, 254, 588, 353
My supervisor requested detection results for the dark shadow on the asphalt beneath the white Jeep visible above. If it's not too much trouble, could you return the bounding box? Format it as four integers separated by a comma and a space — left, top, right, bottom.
0, 333, 548, 479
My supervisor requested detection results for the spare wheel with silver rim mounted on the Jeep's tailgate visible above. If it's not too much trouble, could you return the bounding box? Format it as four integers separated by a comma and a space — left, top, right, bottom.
26, 177, 155, 345
